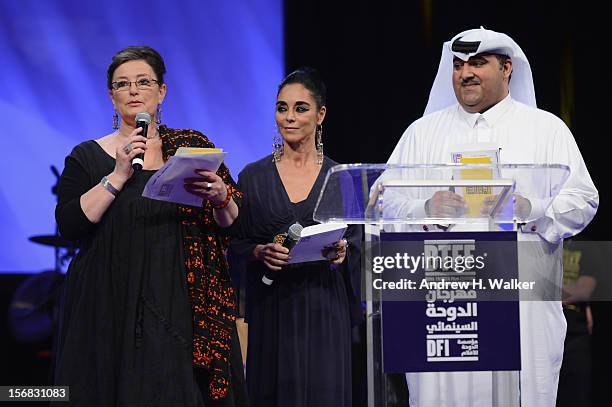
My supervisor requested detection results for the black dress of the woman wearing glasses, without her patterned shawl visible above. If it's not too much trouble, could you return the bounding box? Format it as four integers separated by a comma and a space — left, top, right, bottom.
55, 132, 246, 407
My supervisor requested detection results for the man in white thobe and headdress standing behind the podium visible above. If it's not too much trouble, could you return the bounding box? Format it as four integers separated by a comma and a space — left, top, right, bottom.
386, 27, 599, 407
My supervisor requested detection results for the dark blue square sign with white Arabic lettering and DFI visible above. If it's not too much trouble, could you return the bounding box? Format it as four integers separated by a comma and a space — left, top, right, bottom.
380, 232, 521, 373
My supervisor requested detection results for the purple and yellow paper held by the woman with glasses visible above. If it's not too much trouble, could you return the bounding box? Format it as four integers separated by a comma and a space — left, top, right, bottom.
142, 147, 227, 206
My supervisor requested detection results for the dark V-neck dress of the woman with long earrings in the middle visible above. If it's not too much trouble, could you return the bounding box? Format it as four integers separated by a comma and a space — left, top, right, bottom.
230, 156, 361, 407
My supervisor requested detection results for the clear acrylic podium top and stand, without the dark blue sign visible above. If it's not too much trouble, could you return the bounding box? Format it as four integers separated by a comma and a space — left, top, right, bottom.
314, 164, 569, 407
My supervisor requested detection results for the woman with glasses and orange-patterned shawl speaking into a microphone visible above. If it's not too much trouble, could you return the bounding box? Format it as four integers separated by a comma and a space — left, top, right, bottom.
55, 46, 246, 406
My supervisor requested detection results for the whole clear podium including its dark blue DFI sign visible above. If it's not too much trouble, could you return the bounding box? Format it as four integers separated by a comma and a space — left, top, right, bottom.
313, 164, 569, 407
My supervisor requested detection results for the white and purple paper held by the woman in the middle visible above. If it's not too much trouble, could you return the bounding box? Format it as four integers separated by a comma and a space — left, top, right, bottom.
289, 223, 348, 264
